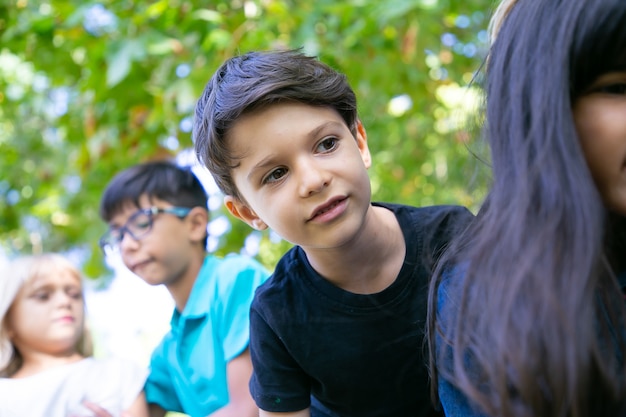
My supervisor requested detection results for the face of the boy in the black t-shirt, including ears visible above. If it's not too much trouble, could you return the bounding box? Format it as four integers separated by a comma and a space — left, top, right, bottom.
225, 102, 371, 249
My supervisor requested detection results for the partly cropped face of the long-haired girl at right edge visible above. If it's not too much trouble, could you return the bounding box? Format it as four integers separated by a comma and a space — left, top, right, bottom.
574, 71, 626, 216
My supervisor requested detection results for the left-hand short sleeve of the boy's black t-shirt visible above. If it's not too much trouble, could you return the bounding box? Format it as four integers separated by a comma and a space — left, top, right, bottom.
250, 301, 311, 412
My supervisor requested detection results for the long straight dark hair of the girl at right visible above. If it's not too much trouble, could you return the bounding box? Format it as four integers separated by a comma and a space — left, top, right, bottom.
428, 0, 626, 417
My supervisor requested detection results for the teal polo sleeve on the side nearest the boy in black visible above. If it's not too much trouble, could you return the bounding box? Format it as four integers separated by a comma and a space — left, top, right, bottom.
217, 256, 269, 362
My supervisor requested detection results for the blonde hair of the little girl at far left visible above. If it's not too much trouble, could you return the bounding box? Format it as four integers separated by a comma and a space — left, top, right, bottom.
0, 253, 93, 377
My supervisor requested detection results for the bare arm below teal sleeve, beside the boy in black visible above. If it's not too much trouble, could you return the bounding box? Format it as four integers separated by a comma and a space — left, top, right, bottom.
210, 349, 259, 417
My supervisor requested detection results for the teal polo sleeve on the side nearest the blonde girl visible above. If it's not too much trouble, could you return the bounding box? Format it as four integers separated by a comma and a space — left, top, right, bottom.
144, 336, 184, 412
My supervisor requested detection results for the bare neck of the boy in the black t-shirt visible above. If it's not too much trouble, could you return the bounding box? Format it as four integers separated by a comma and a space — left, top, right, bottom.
303, 206, 406, 294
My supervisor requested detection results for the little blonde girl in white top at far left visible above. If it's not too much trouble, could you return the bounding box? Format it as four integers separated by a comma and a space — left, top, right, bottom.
0, 254, 148, 417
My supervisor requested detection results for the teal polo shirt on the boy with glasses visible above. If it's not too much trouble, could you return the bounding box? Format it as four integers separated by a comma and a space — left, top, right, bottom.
145, 254, 268, 417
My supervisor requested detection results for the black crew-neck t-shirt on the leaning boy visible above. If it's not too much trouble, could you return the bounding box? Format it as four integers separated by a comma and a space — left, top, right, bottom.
250, 204, 472, 417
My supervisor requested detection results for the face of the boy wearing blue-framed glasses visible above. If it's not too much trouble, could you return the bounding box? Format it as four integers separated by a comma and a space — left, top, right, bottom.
109, 194, 208, 285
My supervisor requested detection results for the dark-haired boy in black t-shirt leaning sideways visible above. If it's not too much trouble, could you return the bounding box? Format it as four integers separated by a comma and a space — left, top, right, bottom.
193, 51, 472, 417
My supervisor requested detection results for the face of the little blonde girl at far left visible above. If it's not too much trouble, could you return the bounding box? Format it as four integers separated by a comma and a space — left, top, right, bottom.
6, 268, 84, 356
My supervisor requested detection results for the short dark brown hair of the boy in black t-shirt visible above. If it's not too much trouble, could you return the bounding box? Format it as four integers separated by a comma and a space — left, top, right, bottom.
193, 50, 357, 198
